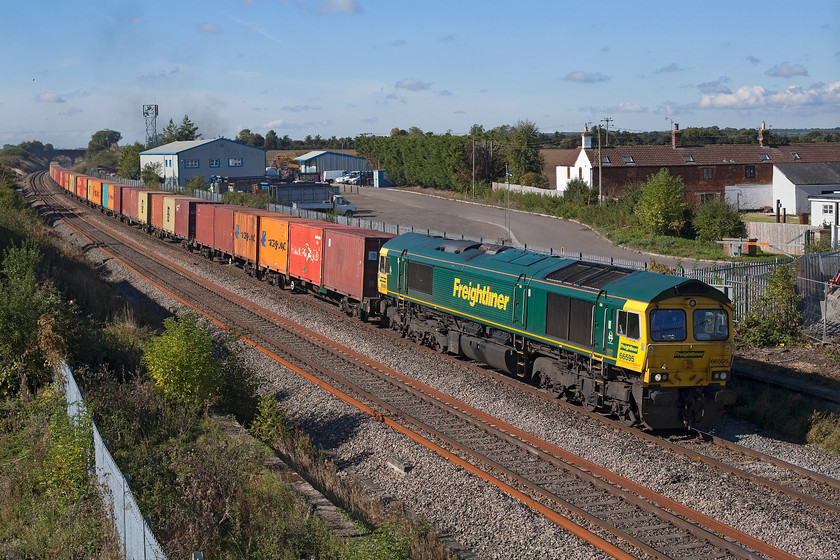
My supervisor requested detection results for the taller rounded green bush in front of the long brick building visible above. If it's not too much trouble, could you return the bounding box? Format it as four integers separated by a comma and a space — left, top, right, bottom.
636, 168, 686, 235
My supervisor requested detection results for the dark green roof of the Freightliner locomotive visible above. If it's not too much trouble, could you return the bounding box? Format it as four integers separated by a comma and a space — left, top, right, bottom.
384, 233, 729, 303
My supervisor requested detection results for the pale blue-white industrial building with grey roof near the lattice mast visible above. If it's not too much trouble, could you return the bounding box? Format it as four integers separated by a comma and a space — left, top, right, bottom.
140, 138, 265, 188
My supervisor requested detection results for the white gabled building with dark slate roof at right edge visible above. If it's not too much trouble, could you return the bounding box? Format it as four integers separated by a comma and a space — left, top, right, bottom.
773, 162, 840, 214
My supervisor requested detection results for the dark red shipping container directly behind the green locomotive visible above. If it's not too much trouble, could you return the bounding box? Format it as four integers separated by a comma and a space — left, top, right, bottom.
321, 228, 395, 302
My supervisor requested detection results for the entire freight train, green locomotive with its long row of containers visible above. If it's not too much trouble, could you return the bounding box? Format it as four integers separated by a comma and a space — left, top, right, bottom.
50, 164, 735, 430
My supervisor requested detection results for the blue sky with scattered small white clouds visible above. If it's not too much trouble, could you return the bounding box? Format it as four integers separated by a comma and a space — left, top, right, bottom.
0, 0, 840, 148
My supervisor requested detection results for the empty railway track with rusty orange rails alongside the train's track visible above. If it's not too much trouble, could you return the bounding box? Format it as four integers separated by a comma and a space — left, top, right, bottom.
27, 173, 828, 558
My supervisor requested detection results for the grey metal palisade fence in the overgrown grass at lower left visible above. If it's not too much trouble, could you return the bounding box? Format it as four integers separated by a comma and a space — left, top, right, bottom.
56, 362, 166, 560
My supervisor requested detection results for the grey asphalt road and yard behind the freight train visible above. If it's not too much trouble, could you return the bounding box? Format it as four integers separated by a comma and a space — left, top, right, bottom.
343, 187, 677, 266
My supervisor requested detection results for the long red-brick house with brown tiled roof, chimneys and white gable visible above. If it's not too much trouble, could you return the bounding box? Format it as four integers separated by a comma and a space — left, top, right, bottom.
556, 123, 840, 209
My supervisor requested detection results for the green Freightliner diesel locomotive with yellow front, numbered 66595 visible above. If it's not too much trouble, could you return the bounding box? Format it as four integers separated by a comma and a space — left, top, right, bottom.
378, 233, 735, 429
